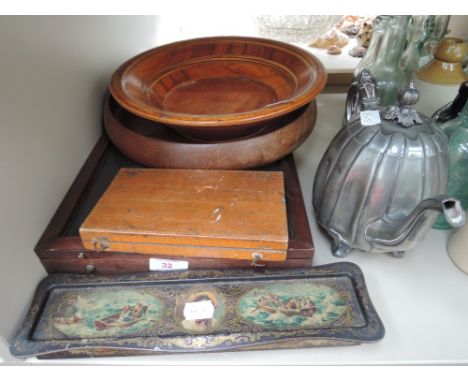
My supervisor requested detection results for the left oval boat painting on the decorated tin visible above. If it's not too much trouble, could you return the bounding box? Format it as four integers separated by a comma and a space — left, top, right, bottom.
53, 289, 163, 338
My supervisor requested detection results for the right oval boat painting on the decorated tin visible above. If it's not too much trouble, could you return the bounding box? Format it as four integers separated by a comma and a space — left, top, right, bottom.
239, 282, 346, 329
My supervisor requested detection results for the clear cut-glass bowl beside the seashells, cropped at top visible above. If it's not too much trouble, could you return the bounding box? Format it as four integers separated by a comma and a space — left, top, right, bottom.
256, 15, 343, 44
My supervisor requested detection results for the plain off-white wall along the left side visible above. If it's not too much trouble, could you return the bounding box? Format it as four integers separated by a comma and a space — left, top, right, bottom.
0, 16, 157, 361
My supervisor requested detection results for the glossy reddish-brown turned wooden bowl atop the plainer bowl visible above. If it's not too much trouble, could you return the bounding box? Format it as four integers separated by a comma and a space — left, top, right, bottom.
110, 37, 327, 140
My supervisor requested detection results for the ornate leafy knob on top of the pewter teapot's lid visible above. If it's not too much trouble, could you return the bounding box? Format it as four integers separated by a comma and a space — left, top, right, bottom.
383, 81, 423, 127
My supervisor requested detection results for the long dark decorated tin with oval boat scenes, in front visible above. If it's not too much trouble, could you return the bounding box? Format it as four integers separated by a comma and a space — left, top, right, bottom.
11, 262, 384, 358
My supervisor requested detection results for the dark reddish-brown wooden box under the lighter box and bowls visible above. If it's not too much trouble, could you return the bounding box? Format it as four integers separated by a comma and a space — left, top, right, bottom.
35, 135, 314, 274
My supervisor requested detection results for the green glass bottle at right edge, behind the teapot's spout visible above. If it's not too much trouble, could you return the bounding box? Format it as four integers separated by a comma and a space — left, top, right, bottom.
433, 104, 468, 229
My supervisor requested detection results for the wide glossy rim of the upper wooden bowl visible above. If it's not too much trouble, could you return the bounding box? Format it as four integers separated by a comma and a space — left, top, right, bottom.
110, 36, 327, 128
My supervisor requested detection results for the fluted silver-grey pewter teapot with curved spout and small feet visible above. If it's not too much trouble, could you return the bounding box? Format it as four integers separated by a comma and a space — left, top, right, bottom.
313, 70, 465, 257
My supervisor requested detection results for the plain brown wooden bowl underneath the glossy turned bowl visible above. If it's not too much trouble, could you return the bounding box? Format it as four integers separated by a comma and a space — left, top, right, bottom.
104, 98, 317, 169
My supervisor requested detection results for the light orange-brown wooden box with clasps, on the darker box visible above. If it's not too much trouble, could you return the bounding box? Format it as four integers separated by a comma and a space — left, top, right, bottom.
80, 168, 288, 261
